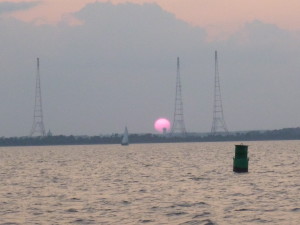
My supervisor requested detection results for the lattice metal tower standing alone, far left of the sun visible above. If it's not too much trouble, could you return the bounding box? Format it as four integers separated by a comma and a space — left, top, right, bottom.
30, 58, 46, 136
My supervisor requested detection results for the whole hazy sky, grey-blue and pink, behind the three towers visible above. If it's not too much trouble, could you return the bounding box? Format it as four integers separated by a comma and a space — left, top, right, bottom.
0, 0, 300, 137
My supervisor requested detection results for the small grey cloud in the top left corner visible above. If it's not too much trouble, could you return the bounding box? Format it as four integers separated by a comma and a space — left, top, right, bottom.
0, 1, 41, 15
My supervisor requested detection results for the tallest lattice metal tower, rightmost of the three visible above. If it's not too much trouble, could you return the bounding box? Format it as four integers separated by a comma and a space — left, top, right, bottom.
211, 51, 228, 135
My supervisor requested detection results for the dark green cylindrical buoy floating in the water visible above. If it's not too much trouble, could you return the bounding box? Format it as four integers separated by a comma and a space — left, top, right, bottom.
233, 144, 249, 173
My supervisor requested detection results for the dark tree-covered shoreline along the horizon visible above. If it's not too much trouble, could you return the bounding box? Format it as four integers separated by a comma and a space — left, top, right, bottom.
0, 127, 300, 147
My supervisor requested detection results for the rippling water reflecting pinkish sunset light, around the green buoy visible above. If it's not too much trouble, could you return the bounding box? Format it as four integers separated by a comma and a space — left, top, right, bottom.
0, 141, 300, 225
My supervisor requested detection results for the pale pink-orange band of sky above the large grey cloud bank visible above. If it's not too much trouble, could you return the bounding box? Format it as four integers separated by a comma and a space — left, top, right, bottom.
5, 0, 300, 38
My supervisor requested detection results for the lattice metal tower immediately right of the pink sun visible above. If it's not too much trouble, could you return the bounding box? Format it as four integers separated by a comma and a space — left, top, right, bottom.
171, 57, 186, 136
